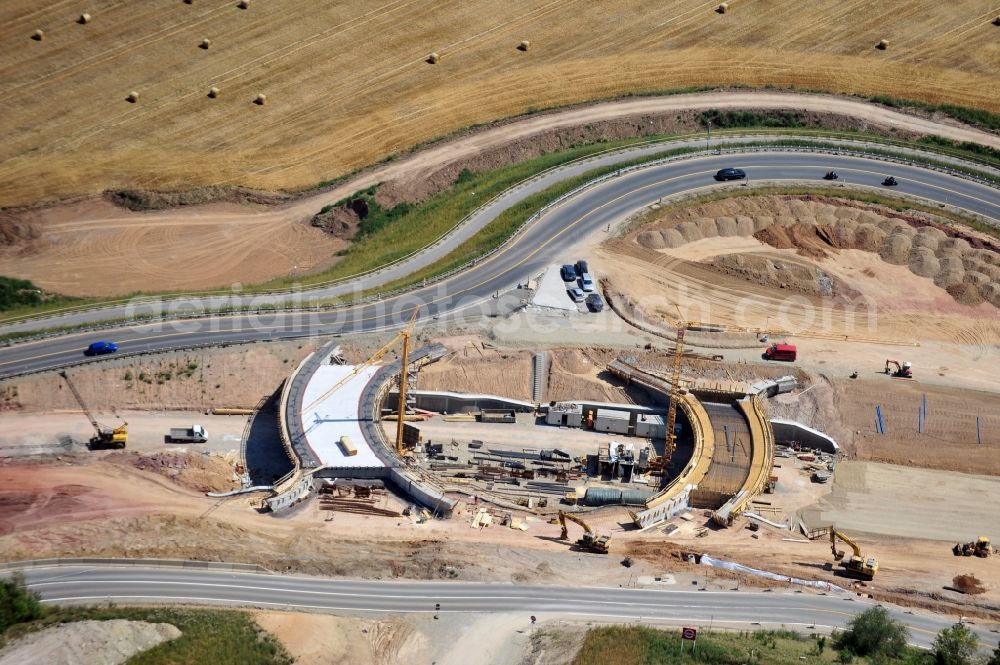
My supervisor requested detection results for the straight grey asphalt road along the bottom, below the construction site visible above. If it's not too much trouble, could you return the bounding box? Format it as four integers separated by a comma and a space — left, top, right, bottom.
17, 566, 1000, 647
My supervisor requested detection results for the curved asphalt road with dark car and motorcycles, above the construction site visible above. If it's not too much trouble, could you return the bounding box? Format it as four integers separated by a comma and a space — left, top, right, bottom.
0, 152, 1000, 378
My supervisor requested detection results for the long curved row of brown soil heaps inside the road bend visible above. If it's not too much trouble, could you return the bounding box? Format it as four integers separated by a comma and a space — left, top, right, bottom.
634, 196, 1000, 307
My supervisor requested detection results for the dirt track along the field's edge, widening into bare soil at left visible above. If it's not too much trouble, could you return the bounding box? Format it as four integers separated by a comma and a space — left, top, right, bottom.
0, 92, 1000, 296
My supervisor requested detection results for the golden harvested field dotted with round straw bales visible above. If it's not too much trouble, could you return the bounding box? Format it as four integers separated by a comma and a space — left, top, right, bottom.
0, 0, 1000, 206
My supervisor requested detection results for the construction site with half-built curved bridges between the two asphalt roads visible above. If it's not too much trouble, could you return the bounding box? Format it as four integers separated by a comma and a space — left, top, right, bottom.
0, 179, 1000, 632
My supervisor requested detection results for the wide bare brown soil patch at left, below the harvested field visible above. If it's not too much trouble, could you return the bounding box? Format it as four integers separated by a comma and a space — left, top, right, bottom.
0, 200, 348, 296
